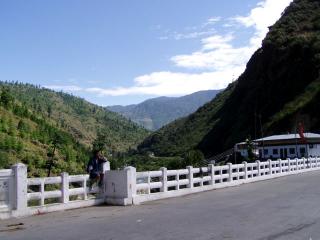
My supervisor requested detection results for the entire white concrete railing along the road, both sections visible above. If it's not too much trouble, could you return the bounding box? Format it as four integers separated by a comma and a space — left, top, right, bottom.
0, 158, 320, 219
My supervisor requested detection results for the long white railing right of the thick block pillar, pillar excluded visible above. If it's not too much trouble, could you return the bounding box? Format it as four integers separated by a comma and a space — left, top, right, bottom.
132, 158, 320, 203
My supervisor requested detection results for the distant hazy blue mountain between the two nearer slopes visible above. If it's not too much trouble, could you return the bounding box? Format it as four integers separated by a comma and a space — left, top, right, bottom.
107, 90, 221, 130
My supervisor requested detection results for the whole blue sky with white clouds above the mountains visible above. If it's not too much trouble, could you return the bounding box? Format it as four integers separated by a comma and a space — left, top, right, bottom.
0, 0, 292, 106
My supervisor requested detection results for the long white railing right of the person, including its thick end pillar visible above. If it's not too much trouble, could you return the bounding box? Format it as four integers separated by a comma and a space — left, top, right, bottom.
105, 158, 320, 205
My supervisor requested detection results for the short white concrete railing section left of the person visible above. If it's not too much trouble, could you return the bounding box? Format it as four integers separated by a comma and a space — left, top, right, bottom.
0, 162, 110, 219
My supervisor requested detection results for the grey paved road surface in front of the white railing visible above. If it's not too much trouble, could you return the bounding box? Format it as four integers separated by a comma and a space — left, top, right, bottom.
0, 171, 320, 240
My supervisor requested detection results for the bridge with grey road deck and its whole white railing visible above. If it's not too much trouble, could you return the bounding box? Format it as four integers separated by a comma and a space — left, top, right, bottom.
0, 158, 320, 239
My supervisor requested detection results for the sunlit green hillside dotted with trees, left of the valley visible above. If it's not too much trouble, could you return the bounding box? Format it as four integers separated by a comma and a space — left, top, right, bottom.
0, 82, 148, 176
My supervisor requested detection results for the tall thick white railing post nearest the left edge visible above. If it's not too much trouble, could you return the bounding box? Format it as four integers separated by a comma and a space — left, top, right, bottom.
12, 163, 28, 216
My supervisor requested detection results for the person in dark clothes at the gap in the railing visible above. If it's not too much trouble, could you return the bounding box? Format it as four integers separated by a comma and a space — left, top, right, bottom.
87, 150, 107, 189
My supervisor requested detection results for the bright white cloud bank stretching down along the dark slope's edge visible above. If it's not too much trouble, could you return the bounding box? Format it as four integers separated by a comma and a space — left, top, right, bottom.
45, 0, 292, 96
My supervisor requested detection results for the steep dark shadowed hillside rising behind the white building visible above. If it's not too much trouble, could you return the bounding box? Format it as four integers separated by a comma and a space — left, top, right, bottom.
139, 0, 320, 157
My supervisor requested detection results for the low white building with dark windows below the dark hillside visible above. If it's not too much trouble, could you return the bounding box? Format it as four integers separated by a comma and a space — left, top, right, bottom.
235, 133, 320, 159
